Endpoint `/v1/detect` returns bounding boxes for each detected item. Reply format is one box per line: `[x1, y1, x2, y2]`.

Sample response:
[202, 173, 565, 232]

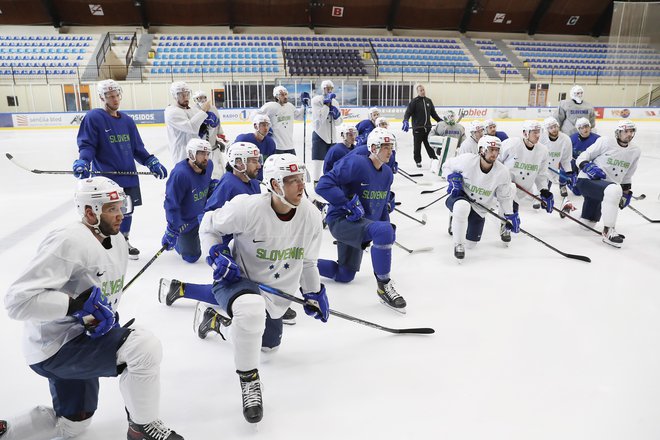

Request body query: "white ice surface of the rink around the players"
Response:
[0, 117, 660, 440]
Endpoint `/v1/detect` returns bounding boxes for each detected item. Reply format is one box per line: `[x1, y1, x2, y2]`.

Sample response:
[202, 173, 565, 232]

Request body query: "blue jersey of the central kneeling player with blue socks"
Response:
[316, 154, 394, 223]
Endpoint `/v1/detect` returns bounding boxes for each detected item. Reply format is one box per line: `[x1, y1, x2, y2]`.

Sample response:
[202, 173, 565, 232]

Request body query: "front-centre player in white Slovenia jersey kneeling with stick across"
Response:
[200, 154, 329, 423]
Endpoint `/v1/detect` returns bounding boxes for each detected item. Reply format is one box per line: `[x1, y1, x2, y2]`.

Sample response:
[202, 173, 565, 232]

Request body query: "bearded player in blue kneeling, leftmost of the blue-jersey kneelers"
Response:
[161, 139, 218, 263]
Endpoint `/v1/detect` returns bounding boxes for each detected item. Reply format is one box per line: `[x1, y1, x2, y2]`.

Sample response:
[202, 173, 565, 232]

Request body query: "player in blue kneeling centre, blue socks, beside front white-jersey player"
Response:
[316, 128, 406, 313]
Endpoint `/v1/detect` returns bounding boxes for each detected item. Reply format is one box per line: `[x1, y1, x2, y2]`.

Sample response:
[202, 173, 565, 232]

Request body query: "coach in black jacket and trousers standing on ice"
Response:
[402, 84, 440, 168]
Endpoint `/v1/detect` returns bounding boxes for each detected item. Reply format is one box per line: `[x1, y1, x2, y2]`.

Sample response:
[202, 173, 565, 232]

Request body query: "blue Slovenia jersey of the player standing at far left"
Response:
[78, 108, 151, 188]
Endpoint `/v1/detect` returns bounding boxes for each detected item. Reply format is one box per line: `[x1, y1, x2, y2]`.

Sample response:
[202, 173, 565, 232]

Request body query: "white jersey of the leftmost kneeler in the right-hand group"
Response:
[442, 154, 513, 217]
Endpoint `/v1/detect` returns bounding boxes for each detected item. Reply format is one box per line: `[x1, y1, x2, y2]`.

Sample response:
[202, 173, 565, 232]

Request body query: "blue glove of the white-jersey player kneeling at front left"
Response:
[67, 286, 119, 339]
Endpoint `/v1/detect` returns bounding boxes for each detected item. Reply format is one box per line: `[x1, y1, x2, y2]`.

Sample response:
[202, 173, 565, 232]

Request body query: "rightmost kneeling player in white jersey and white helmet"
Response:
[571, 120, 641, 247]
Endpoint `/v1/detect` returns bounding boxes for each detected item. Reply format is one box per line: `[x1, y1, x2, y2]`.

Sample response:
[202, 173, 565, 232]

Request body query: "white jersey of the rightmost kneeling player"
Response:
[575, 136, 642, 184]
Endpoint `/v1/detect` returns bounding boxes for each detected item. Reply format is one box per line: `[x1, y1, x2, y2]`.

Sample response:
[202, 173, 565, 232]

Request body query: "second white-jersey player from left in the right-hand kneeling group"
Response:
[499, 120, 554, 242]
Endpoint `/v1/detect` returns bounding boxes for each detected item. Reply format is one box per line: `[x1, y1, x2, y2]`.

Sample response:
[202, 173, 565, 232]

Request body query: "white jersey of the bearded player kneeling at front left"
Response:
[5, 222, 128, 365]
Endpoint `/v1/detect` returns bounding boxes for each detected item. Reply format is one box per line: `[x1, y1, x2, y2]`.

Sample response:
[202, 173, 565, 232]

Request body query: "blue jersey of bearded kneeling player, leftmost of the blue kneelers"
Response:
[164, 159, 213, 233]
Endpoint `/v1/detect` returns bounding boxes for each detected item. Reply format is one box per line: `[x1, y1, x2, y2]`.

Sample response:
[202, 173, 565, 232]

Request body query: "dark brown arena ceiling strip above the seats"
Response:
[0, 0, 628, 37]
